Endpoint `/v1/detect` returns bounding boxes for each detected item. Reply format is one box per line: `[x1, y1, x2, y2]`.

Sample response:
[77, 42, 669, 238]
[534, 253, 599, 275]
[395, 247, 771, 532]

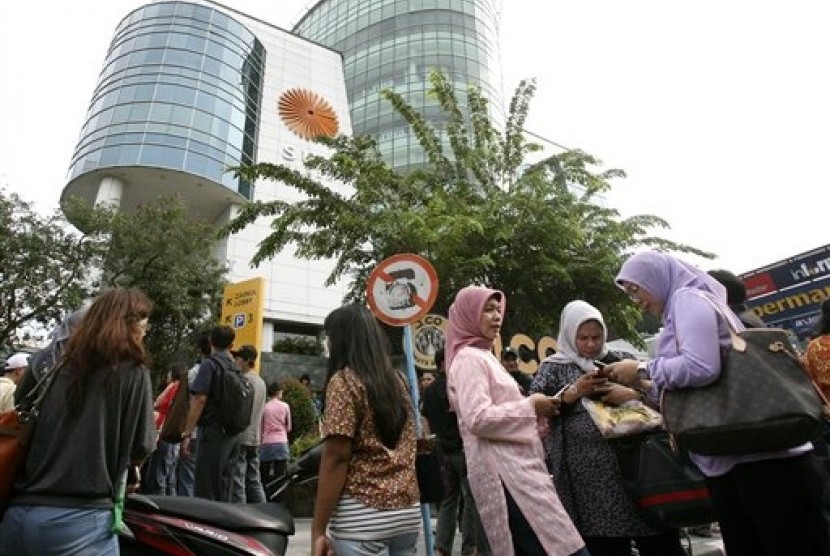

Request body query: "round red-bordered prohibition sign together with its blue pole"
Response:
[366, 253, 438, 556]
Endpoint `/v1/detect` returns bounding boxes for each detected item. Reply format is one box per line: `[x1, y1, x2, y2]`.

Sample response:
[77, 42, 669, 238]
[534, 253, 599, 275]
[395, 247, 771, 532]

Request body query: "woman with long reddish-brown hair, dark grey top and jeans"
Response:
[0, 288, 155, 556]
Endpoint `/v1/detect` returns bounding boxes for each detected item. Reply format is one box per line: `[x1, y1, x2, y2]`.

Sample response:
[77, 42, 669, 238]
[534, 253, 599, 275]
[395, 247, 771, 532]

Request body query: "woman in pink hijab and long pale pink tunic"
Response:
[445, 286, 588, 556]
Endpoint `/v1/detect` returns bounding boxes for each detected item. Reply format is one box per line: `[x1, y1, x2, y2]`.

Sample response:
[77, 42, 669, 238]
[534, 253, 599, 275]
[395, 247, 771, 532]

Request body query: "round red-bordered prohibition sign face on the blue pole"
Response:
[366, 253, 438, 326]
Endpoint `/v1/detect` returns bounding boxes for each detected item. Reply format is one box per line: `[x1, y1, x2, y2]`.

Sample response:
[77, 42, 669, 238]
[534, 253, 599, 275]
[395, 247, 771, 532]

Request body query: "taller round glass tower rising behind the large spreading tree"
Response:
[293, 0, 504, 169]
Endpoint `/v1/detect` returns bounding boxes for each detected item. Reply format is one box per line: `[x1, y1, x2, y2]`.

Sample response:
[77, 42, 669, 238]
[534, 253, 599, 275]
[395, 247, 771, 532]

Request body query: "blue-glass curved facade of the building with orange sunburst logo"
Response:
[69, 2, 265, 199]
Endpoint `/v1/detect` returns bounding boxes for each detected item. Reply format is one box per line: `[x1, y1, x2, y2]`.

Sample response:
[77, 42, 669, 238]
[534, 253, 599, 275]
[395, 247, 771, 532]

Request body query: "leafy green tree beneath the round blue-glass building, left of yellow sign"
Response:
[64, 196, 226, 384]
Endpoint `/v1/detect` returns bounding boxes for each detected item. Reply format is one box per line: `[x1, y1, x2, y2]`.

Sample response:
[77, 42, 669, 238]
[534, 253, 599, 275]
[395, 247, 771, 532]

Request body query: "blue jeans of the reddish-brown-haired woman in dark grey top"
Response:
[0, 506, 118, 556]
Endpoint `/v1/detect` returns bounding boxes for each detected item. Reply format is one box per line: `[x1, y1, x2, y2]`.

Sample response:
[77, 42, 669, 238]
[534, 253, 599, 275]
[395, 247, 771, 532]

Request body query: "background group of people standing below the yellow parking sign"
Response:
[135, 326, 291, 503]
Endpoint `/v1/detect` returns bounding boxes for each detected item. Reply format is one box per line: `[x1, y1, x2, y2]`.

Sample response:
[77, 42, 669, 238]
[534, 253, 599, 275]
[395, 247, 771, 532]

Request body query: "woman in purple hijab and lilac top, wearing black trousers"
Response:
[606, 251, 830, 556]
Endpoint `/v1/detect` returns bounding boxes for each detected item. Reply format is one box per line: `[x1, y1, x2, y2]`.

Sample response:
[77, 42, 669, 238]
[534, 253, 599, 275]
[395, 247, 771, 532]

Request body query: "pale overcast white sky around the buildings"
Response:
[0, 0, 830, 273]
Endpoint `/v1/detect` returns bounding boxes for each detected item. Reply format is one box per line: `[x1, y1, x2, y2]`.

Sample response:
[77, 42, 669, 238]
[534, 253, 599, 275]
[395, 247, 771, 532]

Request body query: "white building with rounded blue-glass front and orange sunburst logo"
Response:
[63, 0, 351, 338]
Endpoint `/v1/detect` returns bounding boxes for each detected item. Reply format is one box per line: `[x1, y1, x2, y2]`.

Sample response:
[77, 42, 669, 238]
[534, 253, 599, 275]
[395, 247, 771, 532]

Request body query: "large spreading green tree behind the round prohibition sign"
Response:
[228, 72, 711, 340]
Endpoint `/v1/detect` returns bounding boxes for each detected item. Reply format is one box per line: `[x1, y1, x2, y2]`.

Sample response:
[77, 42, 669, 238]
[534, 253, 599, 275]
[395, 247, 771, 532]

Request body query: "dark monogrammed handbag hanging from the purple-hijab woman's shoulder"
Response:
[661, 294, 822, 456]
